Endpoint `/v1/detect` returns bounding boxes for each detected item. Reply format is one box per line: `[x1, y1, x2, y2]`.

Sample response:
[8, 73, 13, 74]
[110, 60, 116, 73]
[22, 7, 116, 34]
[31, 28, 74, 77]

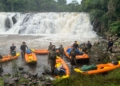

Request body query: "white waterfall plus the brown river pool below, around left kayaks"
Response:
[0, 12, 98, 73]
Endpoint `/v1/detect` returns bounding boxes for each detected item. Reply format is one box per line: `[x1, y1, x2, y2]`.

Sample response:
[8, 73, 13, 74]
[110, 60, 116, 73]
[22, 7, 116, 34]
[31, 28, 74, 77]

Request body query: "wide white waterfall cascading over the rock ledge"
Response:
[0, 12, 98, 45]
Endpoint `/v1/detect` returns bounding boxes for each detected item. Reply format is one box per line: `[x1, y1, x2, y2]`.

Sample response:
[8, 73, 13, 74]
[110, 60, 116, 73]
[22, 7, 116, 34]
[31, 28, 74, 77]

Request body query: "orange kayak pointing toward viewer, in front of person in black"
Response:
[25, 53, 37, 63]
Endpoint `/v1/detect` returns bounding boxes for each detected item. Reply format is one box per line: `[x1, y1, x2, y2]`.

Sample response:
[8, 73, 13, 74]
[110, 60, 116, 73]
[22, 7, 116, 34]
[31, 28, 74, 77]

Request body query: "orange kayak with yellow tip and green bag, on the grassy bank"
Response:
[74, 61, 120, 75]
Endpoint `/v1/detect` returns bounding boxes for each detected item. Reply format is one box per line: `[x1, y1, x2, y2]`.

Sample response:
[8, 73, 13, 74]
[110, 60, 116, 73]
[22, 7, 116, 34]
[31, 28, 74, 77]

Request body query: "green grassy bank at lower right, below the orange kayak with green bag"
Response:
[53, 69, 120, 86]
